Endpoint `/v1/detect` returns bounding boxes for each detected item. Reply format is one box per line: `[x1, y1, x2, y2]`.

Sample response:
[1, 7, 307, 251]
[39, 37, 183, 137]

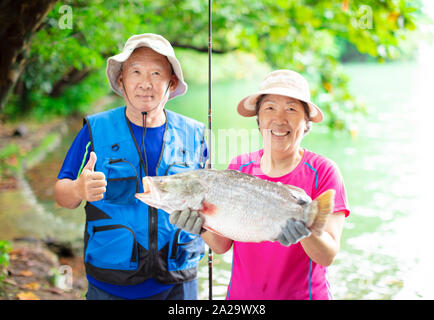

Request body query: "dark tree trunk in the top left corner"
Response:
[0, 0, 57, 111]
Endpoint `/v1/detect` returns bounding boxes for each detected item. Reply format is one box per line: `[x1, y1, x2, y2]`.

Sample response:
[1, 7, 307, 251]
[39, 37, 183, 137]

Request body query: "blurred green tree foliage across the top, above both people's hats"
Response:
[4, 0, 421, 129]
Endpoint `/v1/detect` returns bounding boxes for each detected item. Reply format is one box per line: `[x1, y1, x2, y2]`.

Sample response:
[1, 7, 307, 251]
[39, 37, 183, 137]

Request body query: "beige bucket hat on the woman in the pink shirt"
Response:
[237, 70, 323, 122]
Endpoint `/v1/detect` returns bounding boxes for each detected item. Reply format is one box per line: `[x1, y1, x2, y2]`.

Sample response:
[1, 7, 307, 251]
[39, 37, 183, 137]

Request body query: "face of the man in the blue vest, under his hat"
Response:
[117, 47, 178, 120]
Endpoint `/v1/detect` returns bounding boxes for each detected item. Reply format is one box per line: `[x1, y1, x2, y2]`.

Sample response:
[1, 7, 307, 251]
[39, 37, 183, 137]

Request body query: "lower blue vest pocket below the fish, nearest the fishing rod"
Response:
[168, 229, 205, 271]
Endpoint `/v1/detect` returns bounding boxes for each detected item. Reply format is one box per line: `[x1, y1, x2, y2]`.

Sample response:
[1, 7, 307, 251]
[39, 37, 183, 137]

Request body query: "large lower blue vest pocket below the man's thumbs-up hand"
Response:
[85, 224, 138, 270]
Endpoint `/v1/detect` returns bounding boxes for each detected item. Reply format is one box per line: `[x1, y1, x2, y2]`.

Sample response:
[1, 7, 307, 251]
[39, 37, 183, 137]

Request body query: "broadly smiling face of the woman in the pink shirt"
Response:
[258, 94, 307, 153]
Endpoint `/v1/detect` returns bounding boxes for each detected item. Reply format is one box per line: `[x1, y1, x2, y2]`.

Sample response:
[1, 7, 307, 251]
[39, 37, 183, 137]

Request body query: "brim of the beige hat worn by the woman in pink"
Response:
[237, 88, 324, 123]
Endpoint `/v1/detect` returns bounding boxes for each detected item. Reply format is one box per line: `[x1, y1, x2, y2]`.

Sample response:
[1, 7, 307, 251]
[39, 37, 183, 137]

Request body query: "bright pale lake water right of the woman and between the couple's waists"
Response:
[201, 53, 434, 299]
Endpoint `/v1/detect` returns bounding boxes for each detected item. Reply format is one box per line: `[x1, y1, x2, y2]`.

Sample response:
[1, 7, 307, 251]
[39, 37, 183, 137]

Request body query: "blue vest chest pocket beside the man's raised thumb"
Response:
[104, 159, 139, 205]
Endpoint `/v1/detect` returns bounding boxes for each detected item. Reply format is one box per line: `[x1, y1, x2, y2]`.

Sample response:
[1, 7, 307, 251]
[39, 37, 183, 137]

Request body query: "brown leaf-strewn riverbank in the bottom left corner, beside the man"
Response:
[0, 239, 87, 300]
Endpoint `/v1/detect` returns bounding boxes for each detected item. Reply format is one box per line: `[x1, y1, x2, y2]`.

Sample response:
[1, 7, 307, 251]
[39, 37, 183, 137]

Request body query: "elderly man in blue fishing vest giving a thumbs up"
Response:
[55, 33, 206, 299]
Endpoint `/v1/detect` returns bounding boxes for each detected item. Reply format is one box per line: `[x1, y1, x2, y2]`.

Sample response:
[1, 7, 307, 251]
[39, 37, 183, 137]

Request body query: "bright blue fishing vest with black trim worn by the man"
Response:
[84, 107, 205, 285]
